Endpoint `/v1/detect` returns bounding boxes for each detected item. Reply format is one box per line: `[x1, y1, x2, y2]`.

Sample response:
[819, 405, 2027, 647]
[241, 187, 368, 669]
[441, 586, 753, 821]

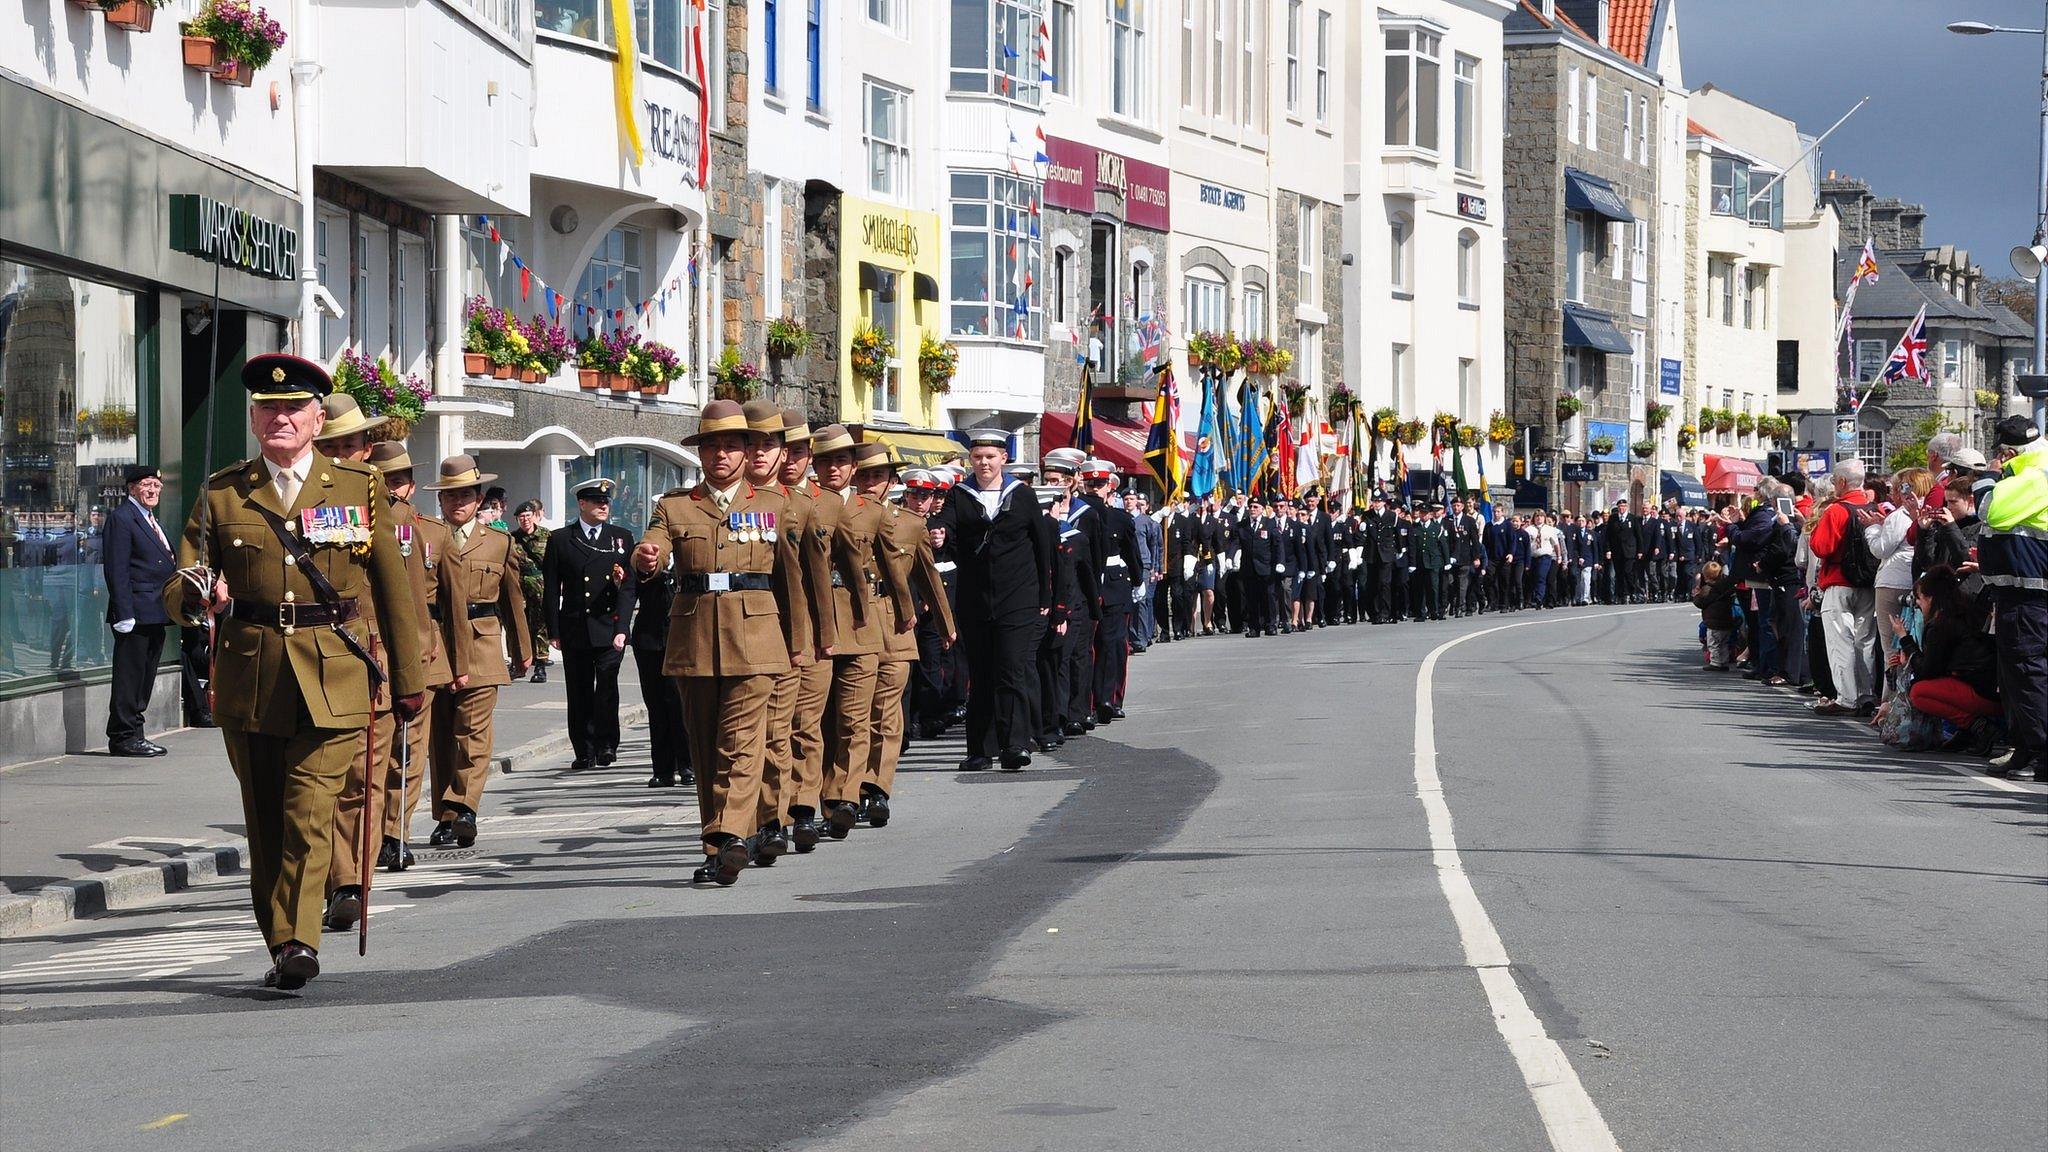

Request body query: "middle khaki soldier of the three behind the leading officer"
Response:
[371, 441, 463, 871]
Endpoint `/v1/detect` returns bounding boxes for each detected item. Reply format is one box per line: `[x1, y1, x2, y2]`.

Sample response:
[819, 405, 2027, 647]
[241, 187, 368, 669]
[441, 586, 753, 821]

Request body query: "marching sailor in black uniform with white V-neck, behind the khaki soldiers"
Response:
[934, 428, 1053, 773]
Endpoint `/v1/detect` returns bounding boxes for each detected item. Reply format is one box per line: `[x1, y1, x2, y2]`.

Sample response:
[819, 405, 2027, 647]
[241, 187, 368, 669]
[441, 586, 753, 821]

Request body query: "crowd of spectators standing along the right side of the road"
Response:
[1694, 416, 2048, 781]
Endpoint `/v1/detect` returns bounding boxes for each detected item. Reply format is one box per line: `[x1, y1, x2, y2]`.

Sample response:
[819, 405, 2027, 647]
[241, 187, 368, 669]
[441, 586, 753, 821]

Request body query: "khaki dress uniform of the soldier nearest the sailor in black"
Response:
[823, 481, 918, 824]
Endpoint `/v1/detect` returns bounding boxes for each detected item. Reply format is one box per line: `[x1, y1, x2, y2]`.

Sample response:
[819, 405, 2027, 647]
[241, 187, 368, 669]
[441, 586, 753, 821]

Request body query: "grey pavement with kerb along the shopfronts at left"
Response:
[0, 660, 647, 939]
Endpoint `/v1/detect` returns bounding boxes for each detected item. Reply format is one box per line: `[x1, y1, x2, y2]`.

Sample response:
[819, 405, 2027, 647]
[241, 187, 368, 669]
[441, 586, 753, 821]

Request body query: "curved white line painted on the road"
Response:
[1415, 605, 1669, 1152]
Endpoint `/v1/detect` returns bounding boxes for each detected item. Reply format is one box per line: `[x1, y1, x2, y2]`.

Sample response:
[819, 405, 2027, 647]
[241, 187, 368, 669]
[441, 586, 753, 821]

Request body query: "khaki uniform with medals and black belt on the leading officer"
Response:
[166, 444, 424, 949]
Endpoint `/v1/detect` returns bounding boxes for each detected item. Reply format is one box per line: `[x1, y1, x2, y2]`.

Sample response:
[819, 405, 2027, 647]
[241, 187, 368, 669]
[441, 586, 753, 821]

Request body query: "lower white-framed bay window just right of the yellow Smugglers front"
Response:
[946, 172, 1040, 342]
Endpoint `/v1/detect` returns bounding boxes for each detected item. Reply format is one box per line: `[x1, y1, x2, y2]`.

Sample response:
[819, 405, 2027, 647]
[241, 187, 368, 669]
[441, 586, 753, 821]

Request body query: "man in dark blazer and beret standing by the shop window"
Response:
[100, 463, 178, 756]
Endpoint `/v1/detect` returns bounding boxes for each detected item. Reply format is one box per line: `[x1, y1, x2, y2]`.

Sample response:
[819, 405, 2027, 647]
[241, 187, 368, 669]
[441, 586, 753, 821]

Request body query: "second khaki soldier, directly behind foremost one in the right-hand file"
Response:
[741, 400, 838, 865]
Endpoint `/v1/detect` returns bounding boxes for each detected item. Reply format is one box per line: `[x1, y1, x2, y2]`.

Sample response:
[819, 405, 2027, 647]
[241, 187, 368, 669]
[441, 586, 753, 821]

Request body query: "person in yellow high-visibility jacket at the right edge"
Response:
[1976, 407, 2048, 781]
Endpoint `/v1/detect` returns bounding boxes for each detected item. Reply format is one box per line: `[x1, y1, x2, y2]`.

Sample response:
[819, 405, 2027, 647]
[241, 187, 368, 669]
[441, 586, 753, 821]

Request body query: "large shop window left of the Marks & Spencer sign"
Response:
[0, 260, 144, 691]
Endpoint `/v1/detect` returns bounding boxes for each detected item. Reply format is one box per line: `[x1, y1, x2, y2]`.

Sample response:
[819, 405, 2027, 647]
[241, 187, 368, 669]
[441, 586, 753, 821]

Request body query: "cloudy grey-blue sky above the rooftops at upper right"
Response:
[1677, 0, 2048, 268]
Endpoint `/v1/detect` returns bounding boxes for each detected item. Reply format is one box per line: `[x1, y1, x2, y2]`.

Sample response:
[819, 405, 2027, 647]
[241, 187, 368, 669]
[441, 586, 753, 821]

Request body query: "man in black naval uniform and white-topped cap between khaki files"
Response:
[541, 476, 639, 771]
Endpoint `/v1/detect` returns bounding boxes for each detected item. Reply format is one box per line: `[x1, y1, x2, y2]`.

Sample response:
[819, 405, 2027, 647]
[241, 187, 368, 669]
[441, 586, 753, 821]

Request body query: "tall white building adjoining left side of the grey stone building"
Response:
[1343, 0, 1513, 486]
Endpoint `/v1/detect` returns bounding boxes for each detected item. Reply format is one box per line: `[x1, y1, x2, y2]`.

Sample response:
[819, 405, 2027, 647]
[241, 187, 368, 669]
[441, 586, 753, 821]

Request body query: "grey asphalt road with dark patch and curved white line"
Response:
[0, 609, 2048, 1152]
